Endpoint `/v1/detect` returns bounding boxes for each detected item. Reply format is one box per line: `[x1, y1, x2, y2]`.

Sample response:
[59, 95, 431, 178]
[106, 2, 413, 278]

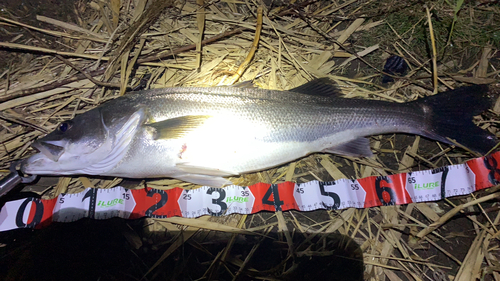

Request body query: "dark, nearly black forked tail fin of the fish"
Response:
[412, 85, 498, 155]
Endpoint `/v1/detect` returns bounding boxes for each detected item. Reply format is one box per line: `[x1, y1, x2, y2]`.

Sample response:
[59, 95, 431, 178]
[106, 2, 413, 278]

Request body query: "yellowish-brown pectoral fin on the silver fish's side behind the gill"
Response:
[145, 115, 211, 140]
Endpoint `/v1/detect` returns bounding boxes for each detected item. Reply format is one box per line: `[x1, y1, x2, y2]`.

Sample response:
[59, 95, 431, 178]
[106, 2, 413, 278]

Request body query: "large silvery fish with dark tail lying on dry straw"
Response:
[21, 78, 498, 187]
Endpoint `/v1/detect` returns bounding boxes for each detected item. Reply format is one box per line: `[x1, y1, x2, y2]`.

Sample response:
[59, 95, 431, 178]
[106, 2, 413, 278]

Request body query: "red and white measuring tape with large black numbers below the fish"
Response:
[0, 152, 500, 231]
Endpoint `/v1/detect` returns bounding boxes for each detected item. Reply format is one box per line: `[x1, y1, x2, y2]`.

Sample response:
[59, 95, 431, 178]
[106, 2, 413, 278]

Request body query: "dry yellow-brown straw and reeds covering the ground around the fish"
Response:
[0, 0, 500, 281]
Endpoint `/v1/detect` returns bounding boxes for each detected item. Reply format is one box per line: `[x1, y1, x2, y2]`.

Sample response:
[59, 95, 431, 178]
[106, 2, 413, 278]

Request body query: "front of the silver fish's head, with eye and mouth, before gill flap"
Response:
[23, 108, 113, 174]
